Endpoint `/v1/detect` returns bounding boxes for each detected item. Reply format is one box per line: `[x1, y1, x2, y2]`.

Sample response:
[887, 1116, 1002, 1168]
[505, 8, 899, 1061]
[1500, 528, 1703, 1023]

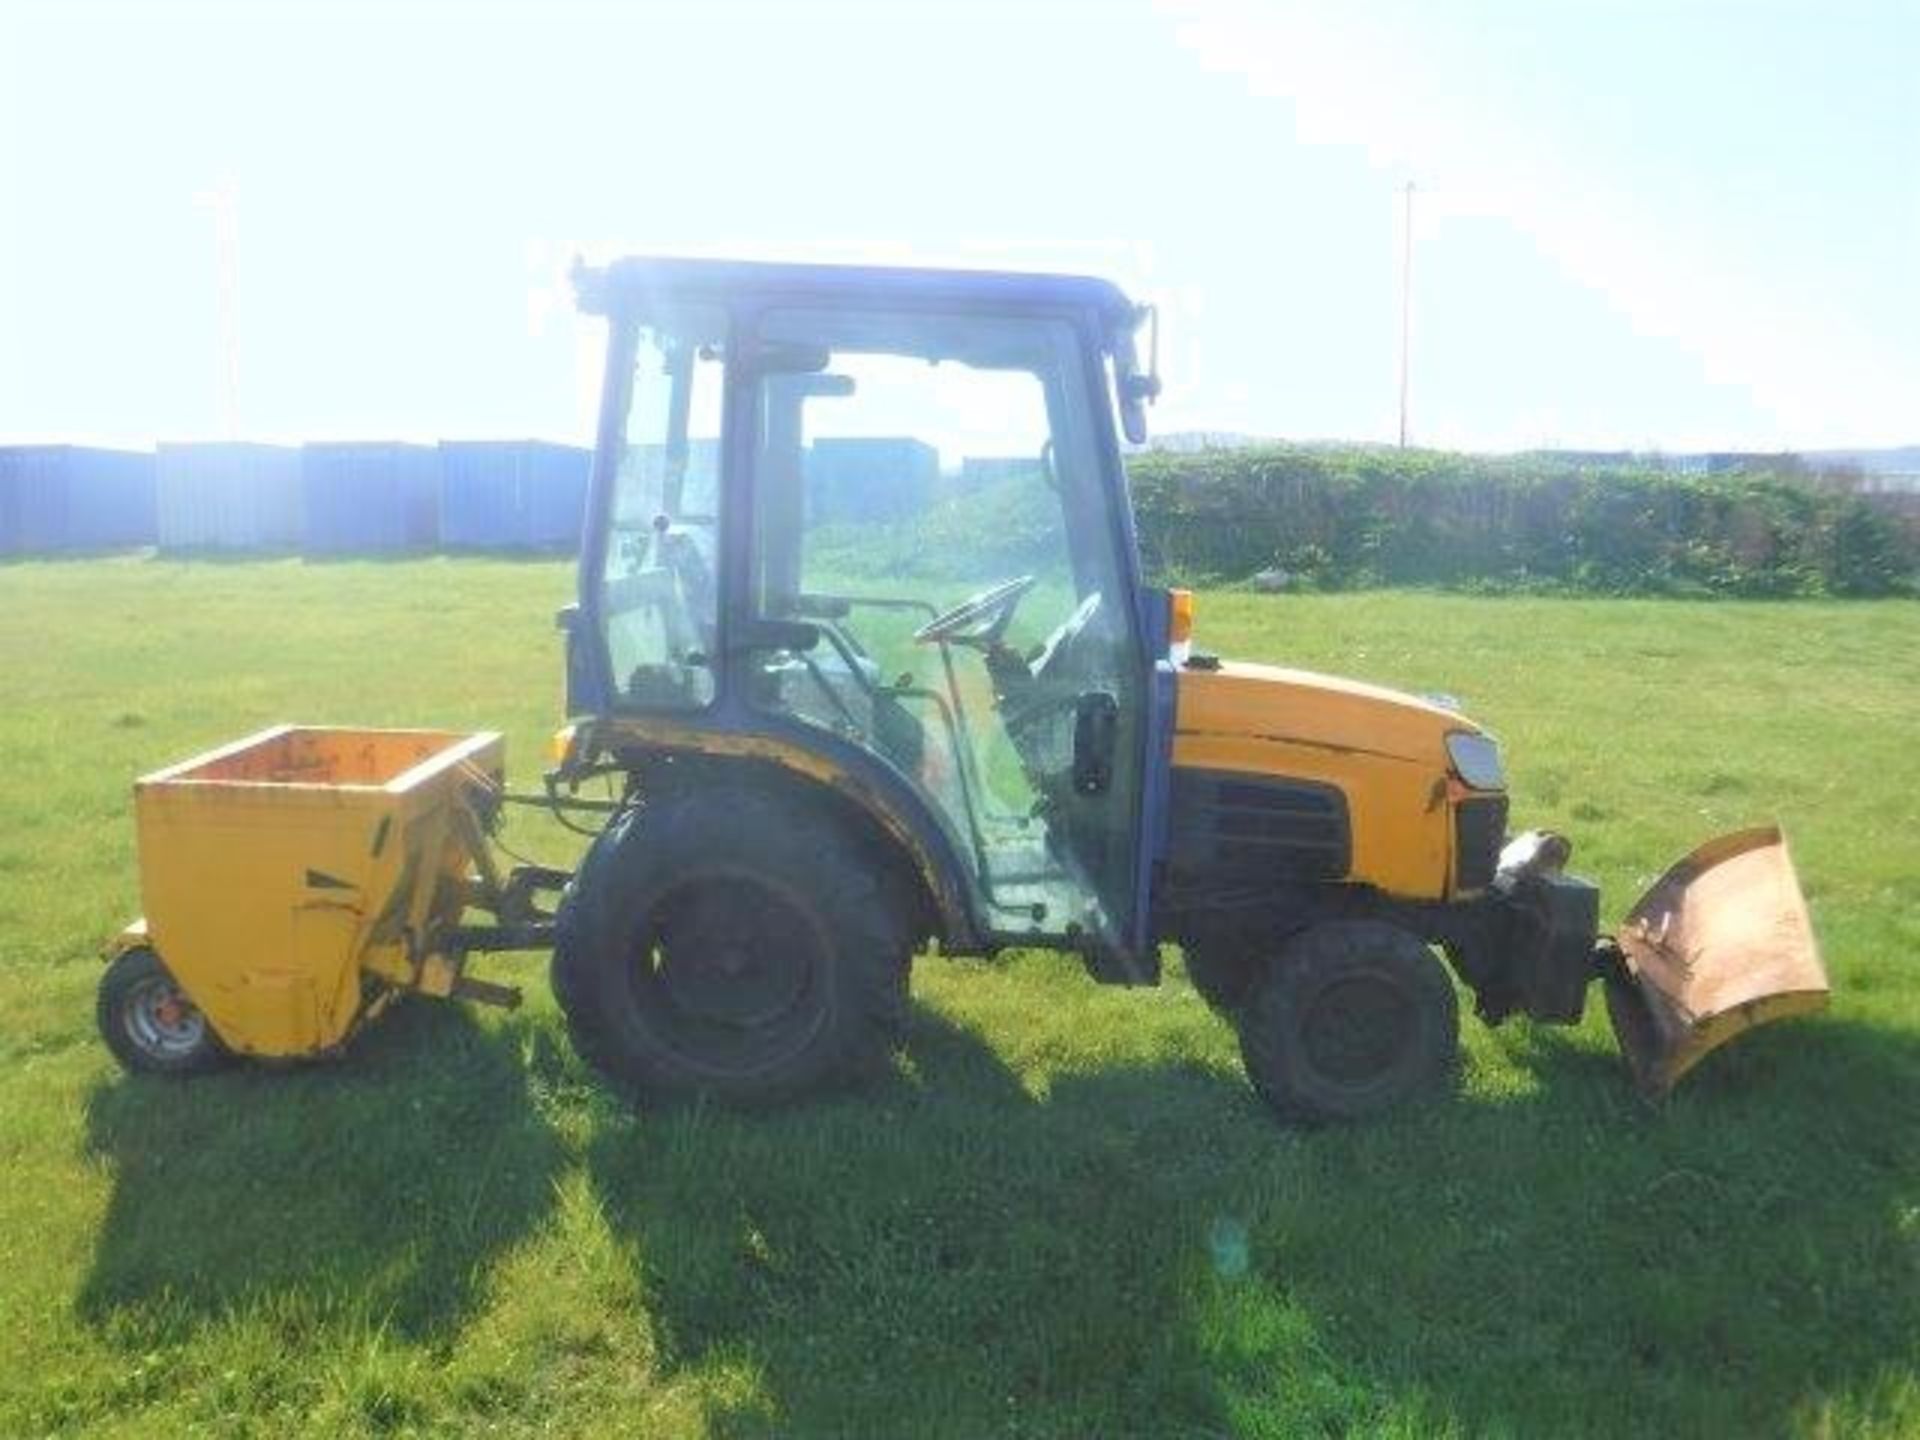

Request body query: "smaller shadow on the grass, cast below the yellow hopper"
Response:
[77, 1004, 564, 1344]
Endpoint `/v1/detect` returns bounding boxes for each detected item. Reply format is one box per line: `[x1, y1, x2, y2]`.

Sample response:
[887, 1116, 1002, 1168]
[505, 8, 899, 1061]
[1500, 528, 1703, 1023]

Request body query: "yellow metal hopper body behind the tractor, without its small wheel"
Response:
[121, 726, 505, 1056]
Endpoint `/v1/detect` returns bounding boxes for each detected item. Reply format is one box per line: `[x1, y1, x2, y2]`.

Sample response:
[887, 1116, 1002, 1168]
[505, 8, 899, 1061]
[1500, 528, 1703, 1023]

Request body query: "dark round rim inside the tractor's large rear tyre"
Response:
[632, 876, 829, 1075]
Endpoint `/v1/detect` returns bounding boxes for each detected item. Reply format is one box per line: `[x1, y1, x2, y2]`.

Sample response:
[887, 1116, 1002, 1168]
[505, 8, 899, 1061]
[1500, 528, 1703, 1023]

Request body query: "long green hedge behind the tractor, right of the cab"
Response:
[1127, 445, 1920, 597]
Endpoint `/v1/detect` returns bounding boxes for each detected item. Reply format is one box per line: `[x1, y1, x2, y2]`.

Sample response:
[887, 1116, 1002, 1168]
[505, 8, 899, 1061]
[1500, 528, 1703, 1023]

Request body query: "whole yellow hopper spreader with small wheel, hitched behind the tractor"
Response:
[100, 726, 566, 1073]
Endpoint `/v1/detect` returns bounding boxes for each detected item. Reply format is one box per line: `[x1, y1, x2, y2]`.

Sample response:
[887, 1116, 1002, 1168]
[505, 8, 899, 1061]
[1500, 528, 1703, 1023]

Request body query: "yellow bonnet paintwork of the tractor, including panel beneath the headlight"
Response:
[1173, 662, 1476, 900]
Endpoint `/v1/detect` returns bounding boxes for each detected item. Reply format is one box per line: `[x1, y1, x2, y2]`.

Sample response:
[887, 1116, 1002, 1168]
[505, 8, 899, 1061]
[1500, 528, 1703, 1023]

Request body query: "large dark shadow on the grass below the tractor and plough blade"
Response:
[588, 1006, 1920, 1436]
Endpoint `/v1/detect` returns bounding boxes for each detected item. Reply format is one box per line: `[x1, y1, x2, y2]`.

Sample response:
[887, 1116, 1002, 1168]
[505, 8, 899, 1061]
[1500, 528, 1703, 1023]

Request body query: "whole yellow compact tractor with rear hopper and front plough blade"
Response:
[100, 259, 1826, 1121]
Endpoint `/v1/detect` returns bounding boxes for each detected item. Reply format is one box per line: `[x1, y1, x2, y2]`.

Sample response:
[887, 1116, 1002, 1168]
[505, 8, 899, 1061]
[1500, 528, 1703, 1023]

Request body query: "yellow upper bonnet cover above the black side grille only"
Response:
[1175, 660, 1478, 768]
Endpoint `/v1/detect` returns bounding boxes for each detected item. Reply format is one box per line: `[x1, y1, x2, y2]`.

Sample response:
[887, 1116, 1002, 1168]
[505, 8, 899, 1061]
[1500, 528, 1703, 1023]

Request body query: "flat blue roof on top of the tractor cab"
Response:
[574, 255, 1133, 323]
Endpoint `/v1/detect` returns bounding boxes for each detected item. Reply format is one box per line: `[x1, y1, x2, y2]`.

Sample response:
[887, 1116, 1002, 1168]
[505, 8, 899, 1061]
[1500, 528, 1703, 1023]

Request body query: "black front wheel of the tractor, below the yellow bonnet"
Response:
[1240, 920, 1459, 1125]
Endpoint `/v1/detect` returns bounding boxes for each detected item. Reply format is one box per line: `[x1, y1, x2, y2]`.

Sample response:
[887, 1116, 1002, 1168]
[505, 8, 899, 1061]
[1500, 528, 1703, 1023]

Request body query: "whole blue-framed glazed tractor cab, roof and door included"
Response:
[570, 261, 1165, 964]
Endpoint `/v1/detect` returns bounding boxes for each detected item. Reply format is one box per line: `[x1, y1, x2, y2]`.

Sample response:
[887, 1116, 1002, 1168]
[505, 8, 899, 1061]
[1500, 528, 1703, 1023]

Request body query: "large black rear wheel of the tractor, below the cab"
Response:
[553, 785, 912, 1104]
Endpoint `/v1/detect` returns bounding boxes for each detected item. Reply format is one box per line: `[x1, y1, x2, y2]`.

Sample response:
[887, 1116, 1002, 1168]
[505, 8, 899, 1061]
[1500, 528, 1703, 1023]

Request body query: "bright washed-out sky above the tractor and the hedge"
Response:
[0, 0, 1920, 449]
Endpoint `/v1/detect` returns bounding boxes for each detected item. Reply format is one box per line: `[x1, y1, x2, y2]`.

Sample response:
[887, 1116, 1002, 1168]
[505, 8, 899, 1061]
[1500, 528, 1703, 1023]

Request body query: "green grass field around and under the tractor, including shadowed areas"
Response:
[0, 561, 1920, 1436]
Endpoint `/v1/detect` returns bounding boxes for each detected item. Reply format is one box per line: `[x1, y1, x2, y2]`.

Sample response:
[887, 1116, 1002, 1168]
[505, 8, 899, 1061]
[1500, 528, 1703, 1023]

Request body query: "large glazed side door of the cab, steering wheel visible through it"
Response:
[733, 305, 1148, 954]
